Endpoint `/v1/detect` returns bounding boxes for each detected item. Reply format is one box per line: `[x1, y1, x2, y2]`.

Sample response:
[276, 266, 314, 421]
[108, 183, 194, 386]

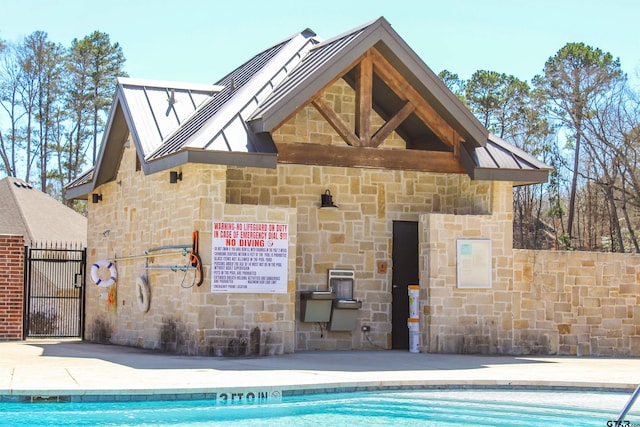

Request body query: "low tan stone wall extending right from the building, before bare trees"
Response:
[513, 250, 640, 356]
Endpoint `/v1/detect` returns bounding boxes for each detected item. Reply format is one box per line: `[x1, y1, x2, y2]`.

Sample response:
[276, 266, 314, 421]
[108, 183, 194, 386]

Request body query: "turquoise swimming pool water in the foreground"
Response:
[0, 389, 640, 427]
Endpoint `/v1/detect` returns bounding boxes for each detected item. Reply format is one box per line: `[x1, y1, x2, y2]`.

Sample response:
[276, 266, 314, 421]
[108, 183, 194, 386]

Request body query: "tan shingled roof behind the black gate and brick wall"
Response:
[0, 177, 87, 245]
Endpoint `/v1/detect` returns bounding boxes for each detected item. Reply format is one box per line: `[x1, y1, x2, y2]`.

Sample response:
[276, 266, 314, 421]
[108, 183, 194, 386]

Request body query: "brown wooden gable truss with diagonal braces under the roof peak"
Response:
[277, 48, 466, 173]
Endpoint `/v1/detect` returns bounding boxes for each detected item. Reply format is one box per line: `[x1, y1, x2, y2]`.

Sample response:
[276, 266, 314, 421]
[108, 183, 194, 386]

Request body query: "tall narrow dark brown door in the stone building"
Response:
[391, 221, 419, 350]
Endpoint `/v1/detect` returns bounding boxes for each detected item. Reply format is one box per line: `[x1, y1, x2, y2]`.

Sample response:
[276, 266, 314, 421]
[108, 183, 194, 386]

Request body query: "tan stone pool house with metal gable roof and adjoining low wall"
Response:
[67, 18, 640, 356]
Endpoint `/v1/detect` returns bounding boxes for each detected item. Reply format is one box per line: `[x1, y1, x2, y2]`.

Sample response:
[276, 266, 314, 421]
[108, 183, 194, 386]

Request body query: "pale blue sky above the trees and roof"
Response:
[0, 0, 640, 87]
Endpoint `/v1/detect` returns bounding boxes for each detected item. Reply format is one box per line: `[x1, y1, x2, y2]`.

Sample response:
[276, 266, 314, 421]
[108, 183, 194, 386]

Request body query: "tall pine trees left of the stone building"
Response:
[0, 31, 126, 204]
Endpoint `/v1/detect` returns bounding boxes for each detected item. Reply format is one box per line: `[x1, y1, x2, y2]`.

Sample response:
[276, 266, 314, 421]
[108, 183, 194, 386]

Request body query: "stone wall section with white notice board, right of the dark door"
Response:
[420, 182, 514, 354]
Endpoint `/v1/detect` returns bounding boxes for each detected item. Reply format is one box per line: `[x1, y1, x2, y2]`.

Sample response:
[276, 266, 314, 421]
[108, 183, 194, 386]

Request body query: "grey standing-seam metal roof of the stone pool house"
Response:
[67, 18, 550, 198]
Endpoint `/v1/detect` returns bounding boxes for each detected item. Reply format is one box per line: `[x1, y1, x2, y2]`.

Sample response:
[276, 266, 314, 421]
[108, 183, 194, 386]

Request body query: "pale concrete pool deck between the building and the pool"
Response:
[0, 340, 640, 401]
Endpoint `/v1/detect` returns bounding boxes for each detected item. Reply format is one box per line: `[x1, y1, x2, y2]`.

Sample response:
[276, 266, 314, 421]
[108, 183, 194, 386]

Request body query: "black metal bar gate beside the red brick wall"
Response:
[23, 242, 87, 338]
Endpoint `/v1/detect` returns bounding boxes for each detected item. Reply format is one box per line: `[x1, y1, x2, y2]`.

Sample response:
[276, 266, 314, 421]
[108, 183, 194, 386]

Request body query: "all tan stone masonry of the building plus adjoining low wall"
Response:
[86, 77, 640, 356]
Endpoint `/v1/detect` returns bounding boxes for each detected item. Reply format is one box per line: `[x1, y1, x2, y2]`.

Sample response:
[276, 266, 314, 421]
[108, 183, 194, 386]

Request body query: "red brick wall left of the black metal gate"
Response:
[0, 234, 24, 340]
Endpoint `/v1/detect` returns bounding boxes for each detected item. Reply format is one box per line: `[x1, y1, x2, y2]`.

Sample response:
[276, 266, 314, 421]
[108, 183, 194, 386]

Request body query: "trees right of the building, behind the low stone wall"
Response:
[439, 43, 640, 252]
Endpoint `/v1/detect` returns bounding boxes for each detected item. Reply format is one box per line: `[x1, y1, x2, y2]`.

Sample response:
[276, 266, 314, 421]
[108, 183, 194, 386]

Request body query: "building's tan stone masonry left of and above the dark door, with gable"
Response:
[86, 76, 496, 355]
